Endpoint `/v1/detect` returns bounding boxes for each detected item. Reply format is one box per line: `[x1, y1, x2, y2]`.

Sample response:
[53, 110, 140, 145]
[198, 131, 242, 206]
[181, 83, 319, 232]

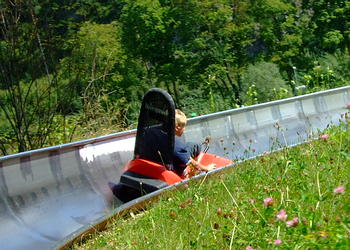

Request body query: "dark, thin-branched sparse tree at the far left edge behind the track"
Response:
[0, 1, 74, 154]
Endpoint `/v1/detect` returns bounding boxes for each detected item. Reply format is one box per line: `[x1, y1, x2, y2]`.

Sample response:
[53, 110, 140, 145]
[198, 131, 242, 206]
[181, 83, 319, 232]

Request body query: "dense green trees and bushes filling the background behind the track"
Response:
[0, 0, 350, 154]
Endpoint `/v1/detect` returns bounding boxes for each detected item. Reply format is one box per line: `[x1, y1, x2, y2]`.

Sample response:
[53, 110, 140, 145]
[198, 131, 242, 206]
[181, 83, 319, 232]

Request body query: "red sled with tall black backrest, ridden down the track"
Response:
[110, 88, 233, 202]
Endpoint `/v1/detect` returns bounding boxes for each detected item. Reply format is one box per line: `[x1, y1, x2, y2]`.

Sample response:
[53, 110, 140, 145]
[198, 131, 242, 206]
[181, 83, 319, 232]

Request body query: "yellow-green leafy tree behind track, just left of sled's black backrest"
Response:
[60, 22, 146, 130]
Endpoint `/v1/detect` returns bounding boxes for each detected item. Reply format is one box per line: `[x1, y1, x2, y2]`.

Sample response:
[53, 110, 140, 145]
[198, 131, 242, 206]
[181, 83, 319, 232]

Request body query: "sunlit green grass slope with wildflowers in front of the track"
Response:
[73, 120, 350, 249]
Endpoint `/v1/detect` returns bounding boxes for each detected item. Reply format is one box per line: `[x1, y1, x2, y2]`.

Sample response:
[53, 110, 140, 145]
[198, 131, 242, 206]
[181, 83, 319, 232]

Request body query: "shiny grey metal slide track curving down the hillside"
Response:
[0, 86, 350, 249]
